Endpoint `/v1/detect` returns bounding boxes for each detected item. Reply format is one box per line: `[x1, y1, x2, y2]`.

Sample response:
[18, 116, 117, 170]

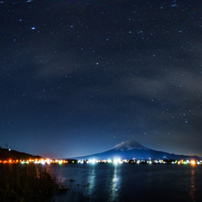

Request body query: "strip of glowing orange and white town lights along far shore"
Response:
[0, 158, 202, 166]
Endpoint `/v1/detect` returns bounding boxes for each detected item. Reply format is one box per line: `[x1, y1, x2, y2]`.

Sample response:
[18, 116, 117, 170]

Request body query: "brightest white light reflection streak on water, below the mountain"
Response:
[110, 165, 121, 201]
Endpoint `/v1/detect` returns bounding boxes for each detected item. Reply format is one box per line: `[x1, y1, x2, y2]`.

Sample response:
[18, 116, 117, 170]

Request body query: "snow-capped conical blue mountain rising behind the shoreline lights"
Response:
[76, 140, 200, 160]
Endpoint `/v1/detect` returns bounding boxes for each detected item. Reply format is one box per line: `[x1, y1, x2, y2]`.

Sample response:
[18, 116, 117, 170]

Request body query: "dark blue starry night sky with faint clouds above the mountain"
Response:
[0, 0, 202, 158]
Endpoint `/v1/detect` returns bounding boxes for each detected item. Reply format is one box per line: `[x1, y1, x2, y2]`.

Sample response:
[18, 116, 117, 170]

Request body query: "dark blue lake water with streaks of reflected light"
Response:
[50, 164, 202, 201]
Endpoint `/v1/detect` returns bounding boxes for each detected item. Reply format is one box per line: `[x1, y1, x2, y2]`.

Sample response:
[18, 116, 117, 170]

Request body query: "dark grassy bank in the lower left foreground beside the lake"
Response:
[0, 164, 58, 201]
